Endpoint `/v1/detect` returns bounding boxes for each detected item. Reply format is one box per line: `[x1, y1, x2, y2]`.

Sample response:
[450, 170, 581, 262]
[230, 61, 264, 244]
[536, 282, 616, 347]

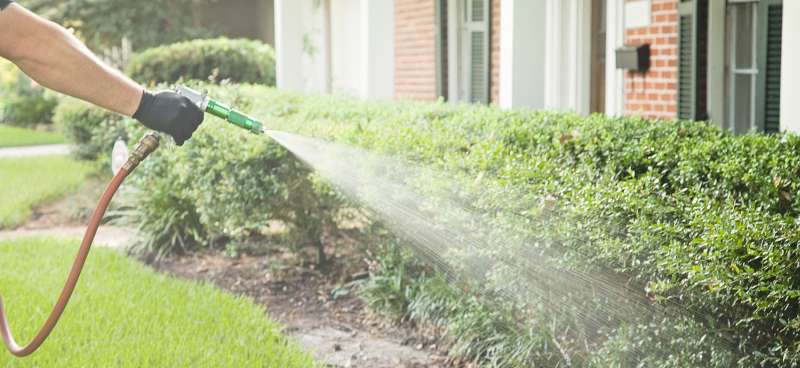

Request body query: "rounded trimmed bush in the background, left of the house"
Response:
[127, 38, 275, 86]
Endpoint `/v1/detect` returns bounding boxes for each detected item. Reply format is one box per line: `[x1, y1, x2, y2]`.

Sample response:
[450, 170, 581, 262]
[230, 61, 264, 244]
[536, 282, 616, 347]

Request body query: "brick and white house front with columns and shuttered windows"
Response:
[274, 0, 800, 132]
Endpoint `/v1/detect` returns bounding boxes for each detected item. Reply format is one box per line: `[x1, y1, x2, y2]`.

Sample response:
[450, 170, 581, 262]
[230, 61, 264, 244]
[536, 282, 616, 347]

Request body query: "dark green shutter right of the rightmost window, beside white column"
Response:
[764, 3, 783, 133]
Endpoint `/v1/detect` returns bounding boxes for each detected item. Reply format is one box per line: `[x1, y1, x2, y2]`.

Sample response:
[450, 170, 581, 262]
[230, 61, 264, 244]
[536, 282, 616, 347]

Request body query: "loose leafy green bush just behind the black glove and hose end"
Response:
[57, 85, 341, 266]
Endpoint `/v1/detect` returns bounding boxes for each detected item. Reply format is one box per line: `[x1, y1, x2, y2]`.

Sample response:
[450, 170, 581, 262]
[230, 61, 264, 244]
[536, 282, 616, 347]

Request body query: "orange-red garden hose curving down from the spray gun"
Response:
[0, 133, 158, 357]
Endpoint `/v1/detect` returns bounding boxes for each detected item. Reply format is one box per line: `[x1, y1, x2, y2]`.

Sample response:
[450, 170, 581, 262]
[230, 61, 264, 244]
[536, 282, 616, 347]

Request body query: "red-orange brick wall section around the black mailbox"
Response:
[625, 0, 678, 119]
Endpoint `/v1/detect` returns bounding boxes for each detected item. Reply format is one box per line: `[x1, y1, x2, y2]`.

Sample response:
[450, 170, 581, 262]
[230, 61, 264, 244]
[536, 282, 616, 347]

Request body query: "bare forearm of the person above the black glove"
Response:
[0, 4, 143, 116]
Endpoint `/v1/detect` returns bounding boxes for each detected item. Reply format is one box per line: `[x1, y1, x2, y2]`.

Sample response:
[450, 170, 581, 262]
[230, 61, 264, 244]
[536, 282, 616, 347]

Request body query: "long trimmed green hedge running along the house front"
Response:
[241, 85, 800, 366]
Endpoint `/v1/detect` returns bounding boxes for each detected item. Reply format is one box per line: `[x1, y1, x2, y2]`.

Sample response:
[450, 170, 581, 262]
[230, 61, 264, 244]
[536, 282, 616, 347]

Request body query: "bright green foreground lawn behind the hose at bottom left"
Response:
[0, 239, 314, 368]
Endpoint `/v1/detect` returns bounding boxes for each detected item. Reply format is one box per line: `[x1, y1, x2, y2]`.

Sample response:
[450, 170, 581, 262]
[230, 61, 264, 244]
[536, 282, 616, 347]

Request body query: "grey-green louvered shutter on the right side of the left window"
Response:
[466, 0, 491, 103]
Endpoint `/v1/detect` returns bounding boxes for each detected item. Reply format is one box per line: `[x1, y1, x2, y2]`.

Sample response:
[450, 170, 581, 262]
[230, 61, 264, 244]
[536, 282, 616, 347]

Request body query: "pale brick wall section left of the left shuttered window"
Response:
[394, 0, 436, 100]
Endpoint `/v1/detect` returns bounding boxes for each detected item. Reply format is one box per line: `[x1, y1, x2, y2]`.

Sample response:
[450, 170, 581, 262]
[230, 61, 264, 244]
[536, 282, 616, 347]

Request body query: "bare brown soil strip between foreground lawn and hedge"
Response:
[153, 250, 462, 368]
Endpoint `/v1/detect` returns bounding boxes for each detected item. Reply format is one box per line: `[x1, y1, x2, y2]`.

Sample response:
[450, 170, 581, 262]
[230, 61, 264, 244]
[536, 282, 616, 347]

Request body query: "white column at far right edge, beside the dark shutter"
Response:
[781, 0, 800, 133]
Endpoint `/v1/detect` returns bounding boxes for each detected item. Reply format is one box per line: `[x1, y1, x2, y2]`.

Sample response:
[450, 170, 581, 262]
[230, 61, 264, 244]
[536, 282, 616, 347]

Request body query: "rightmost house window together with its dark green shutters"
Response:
[678, 0, 783, 133]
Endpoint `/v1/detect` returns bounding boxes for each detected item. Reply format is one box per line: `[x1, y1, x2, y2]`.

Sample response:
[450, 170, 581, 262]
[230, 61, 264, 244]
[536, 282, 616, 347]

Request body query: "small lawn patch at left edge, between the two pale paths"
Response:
[0, 156, 92, 229]
